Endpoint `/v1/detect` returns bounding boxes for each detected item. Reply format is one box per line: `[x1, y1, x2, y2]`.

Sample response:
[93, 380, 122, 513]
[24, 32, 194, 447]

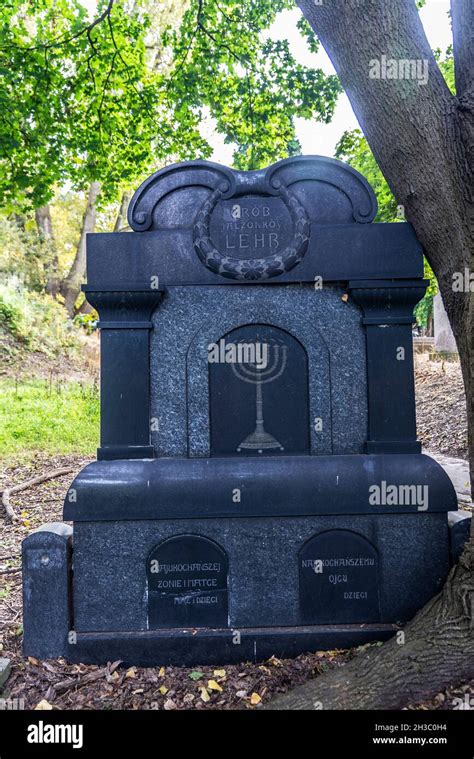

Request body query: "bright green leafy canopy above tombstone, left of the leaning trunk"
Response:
[0, 0, 340, 210]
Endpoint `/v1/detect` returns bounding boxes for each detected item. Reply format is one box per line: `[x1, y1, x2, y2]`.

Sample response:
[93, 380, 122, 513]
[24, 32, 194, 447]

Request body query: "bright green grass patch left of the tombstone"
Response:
[0, 379, 99, 458]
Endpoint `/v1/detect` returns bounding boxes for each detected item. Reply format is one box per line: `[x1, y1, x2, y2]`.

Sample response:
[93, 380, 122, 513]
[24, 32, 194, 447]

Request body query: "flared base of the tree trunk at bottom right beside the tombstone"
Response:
[265, 551, 474, 710]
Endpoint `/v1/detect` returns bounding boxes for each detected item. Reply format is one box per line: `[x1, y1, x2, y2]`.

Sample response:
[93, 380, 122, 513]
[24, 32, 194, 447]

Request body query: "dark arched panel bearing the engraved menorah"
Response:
[208, 323, 311, 456]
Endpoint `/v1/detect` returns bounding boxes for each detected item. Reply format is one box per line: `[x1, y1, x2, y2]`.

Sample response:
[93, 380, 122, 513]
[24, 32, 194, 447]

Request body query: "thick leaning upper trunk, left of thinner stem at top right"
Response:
[298, 0, 474, 348]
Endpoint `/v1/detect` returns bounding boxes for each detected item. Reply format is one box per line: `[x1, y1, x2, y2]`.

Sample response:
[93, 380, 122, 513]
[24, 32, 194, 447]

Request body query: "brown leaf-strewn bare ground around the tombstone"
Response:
[0, 362, 474, 710]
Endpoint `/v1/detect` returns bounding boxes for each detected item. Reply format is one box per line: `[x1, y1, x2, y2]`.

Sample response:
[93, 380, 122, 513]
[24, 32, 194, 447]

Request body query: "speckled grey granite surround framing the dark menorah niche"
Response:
[150, 285, 367, 457]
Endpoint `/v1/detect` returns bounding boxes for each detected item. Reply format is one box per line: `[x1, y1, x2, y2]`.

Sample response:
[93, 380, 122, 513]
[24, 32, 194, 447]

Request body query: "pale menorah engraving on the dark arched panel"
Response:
[232, 344, 287, 453]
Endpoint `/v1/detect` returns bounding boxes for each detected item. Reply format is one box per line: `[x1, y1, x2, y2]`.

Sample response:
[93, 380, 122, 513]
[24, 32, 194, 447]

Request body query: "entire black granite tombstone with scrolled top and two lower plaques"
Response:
[23, 156, 465, 665]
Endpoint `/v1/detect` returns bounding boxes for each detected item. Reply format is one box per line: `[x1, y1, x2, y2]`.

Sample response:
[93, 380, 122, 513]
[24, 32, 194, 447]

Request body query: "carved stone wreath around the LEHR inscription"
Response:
[193, 185, 310, 280]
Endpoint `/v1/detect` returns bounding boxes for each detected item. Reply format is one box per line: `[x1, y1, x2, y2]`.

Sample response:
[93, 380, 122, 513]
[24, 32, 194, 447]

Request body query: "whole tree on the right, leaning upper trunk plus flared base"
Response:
[270, 0, 474, 709]
